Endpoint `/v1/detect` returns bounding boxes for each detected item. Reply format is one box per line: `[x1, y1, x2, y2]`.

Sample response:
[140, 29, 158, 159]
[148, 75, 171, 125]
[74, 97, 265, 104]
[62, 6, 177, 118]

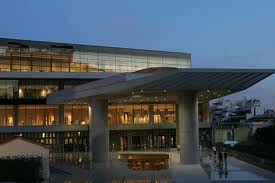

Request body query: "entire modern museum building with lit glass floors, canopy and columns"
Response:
[0, 38, 274, 164]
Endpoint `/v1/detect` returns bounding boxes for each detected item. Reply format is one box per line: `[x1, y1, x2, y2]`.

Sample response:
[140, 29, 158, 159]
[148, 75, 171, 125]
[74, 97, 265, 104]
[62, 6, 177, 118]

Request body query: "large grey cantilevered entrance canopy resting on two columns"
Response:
[47, 69, 275, 104]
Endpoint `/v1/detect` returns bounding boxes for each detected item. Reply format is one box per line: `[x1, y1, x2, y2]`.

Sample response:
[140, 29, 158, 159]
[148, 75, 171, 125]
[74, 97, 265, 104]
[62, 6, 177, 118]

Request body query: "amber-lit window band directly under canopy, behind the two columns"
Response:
[0, 104, 209, 126]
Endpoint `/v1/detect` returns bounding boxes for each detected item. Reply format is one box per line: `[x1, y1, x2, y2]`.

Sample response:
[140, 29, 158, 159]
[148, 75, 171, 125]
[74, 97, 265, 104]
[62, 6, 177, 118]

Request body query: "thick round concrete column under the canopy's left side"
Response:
[89, 99, 109, 165]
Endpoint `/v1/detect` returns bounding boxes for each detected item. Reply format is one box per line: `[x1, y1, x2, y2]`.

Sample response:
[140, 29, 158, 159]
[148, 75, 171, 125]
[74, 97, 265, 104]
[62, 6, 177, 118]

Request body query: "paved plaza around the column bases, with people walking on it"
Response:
[51, 150, 275, 183]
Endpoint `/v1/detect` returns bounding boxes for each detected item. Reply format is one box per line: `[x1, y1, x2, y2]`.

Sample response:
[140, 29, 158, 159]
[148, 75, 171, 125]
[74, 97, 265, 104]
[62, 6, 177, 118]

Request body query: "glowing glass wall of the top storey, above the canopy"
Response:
[0, 46, 191, 72]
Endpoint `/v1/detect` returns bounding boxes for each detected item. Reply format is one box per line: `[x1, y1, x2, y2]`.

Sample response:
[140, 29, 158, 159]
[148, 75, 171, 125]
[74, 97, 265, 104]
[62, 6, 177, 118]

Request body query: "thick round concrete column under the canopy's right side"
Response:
[178, 91, 200, 164]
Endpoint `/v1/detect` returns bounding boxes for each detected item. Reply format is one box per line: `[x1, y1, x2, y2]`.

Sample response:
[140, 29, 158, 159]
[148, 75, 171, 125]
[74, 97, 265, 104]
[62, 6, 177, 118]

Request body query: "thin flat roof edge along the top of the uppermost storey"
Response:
[0, 38, 191, 59]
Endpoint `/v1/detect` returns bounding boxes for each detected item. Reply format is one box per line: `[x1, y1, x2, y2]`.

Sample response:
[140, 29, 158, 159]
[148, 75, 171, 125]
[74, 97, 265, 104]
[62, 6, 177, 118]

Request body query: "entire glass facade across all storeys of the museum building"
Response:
[0, 39, 211, 151]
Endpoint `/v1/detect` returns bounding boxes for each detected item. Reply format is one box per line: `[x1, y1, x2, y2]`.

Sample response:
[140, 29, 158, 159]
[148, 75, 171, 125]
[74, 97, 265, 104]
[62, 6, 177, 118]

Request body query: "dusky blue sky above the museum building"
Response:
[0, 0, 275, 108]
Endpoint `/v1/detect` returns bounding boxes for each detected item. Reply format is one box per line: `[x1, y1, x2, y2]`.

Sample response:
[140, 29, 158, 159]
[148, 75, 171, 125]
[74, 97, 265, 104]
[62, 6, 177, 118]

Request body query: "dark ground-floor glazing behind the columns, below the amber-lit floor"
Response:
[0, 128, 212, 152]
